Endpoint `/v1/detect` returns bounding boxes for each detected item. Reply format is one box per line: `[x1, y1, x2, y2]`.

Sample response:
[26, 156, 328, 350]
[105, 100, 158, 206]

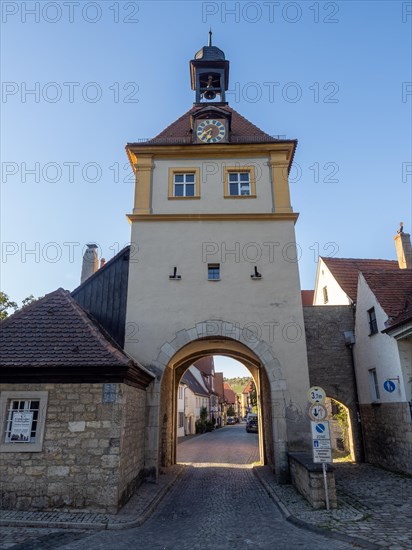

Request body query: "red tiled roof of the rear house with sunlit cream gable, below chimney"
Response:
[322, 257, 400, 302]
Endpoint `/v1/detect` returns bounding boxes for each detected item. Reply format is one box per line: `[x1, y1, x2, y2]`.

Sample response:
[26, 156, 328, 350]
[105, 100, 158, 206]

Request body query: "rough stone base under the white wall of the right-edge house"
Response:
[361, 403, 412, 475]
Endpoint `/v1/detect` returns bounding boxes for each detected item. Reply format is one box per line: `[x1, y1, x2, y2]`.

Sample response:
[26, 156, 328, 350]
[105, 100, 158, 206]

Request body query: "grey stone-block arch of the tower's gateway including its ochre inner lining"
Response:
[146, 319, 288, 480]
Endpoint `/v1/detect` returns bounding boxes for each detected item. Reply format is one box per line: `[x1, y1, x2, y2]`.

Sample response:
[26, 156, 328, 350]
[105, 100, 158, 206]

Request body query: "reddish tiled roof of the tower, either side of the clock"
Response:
[129, 105, 295, 146]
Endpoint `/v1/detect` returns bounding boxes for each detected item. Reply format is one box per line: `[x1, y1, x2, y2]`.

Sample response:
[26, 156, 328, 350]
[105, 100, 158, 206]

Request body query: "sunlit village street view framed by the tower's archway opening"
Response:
[176, 355, 262, 468]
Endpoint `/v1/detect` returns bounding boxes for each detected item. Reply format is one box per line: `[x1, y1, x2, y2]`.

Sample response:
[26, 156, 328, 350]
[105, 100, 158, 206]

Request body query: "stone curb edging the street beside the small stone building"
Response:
[0, 466, 184, 530]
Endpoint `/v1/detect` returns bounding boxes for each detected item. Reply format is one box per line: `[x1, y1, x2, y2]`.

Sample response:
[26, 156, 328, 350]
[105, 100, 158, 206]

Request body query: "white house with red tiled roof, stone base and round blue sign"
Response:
[353, 256, 412, 474]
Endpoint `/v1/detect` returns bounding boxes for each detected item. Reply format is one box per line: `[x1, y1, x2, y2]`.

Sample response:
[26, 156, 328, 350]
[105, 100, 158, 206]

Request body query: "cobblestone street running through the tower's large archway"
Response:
[3, 424, 355, 550]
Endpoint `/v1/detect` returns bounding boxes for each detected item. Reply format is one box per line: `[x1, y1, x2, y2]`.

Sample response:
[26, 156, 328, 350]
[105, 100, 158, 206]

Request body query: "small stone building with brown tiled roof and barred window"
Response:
[0, 289, 154, 512]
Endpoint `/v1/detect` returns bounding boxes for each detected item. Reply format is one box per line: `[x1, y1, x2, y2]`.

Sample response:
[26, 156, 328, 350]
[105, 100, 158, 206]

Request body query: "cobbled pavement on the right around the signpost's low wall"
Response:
[256, 464, 412, 550]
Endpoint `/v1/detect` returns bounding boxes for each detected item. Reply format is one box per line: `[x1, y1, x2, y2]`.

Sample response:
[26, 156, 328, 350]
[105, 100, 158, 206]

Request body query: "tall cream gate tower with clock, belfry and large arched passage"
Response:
[125, 38, 309, 484]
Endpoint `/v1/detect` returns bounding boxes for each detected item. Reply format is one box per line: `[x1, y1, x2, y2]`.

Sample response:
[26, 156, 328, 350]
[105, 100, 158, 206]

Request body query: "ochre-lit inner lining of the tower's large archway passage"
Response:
[159, 338, 276, 476]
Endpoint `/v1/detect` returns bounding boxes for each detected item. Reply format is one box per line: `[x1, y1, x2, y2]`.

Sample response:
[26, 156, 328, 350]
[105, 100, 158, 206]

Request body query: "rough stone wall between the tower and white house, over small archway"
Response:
[303, 306, 363, 461]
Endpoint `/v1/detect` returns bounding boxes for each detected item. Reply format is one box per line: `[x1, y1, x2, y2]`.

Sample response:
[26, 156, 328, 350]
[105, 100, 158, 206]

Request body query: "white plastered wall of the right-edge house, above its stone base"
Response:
[353, 273, 406, 404]
